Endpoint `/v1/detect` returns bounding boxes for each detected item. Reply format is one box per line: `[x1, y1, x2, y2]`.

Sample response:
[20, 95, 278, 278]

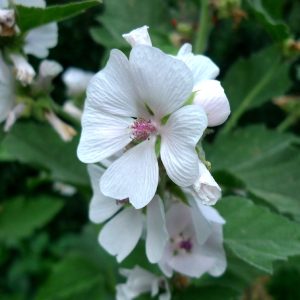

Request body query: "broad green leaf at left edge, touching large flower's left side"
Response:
[0, 122, 89, 185]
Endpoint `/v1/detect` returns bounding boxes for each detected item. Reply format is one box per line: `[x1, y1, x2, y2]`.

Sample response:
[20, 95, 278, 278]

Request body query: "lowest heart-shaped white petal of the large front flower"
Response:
[100, 139, 158, 208]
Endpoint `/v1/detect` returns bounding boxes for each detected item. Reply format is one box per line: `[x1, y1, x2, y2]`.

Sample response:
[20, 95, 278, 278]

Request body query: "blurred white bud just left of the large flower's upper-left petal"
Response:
[62, 68, 94, 96]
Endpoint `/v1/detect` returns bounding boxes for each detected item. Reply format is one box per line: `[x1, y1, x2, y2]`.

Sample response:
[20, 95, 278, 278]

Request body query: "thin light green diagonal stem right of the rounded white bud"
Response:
[222, 63, 277, 134]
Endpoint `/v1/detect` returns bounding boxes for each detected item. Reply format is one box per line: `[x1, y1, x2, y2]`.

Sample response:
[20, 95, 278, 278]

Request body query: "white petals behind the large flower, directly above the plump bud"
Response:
[177, 44, 220, 85]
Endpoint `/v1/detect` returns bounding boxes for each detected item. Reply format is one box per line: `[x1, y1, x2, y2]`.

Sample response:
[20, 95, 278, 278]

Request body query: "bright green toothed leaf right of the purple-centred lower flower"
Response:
[217, 197, 300, 273]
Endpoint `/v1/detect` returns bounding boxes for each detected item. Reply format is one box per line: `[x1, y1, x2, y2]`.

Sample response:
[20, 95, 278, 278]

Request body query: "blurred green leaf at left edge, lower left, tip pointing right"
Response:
[0, 196, 63, 242]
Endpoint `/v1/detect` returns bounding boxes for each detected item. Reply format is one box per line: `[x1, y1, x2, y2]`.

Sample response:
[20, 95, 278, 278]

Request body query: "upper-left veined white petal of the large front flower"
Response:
[86, 49, 146, 117]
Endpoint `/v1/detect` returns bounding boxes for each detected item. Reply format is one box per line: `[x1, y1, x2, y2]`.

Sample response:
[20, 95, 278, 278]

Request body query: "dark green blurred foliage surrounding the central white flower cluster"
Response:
[0, 0, 300, 300]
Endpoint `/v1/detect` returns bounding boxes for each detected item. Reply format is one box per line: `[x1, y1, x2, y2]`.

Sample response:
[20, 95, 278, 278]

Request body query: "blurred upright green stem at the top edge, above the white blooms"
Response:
[194, 0, 211, 53]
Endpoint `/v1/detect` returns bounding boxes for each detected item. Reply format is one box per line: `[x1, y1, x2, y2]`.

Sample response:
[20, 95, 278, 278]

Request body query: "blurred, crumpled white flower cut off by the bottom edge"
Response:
[116, 266, 171, 300]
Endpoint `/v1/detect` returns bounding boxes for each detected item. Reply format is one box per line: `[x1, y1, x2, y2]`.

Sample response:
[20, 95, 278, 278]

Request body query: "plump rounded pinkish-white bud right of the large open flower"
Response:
[194, 80, 230, 127]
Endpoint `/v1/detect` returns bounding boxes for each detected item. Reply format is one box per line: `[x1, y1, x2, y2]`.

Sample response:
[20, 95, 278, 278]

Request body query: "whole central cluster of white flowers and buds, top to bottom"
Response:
[78, 26, 230, 299]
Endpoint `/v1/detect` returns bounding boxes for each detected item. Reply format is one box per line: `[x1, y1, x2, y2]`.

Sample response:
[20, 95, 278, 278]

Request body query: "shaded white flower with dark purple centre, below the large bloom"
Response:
[159, 200, 226, 278]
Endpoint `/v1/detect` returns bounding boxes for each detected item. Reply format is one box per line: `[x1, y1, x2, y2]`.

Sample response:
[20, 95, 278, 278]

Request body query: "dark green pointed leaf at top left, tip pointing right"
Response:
[17, 0, 101, 32]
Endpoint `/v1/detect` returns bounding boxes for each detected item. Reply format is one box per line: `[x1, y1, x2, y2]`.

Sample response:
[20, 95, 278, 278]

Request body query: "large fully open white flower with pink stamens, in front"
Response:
[78, 45, 207, 208]
